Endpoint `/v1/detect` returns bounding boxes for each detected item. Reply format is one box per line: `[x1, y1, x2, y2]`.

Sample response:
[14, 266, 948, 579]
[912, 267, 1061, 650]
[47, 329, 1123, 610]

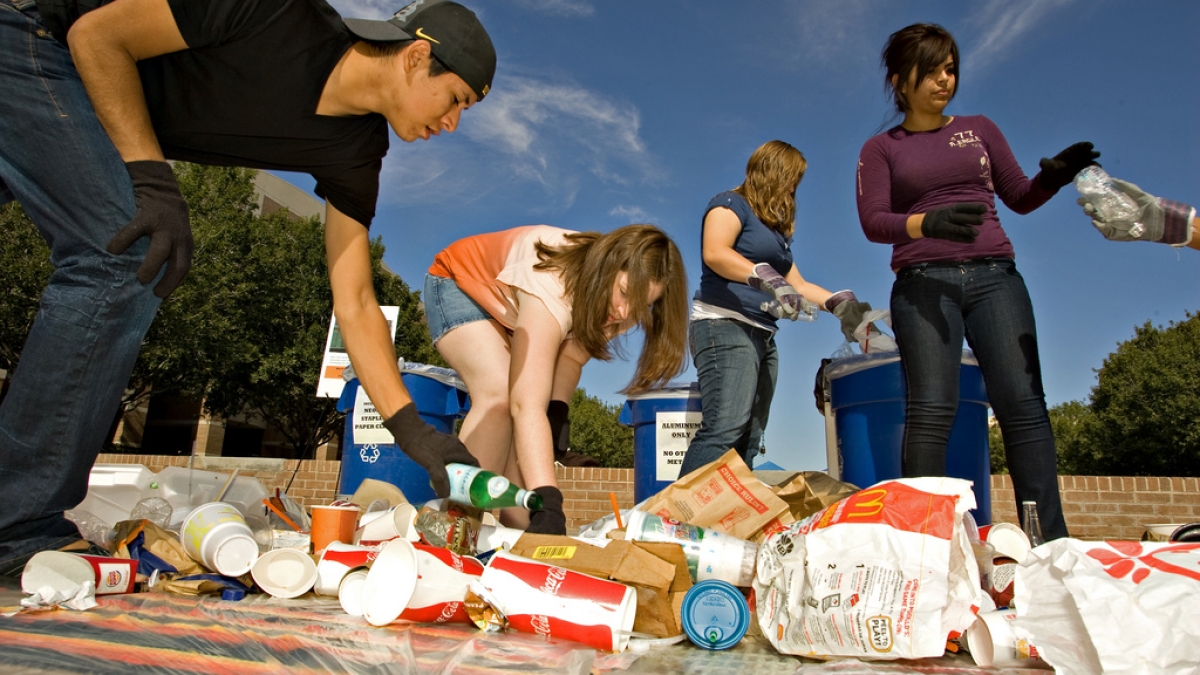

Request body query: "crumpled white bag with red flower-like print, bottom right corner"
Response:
[1013, 539, 1200, 675]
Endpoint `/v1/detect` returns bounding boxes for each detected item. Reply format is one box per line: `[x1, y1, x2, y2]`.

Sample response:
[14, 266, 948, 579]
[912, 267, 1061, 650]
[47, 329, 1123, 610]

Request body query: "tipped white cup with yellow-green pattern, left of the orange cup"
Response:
[179, 502, 258, 577]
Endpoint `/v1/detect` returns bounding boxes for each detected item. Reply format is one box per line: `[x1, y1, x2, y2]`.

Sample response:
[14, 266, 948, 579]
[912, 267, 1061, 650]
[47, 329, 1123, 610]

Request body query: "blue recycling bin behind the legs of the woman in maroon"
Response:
[826, 351, 991, 525]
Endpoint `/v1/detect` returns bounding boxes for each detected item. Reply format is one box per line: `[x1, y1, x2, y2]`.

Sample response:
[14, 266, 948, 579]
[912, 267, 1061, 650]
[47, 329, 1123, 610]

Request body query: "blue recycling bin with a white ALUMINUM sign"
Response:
[617, 382, 701, 502]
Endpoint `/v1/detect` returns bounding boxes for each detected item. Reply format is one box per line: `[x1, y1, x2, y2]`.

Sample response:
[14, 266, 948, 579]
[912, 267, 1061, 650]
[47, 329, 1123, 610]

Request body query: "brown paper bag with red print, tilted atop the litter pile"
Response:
[643, 449, 794, 540]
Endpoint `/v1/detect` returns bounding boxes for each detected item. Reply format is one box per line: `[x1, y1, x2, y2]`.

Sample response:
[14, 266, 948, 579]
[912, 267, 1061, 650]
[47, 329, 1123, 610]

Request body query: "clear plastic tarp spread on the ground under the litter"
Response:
[0, 579, 1046, 675]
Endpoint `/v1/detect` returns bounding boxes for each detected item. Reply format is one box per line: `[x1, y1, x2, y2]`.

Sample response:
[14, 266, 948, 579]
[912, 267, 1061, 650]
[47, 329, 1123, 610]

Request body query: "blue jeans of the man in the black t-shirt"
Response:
[0, 0, 158, 569]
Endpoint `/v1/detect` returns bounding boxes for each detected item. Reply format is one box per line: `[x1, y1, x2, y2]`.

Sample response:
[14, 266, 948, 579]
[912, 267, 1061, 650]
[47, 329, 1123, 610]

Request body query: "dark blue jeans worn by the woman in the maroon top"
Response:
[892, 258, 1067, 540]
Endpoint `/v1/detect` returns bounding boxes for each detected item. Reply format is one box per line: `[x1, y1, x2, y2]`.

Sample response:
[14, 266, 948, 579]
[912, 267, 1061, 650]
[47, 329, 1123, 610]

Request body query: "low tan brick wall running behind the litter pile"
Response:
[97, 454, 1200, 539]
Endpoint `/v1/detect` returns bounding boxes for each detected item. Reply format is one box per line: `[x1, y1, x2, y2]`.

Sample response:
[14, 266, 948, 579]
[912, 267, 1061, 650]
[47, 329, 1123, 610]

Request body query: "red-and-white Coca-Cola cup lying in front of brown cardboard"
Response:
[480, 551, 637, 651]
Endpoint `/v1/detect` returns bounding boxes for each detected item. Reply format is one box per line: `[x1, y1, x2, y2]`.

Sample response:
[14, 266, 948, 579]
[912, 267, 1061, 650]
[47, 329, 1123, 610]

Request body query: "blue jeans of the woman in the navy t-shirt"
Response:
[679, 318, 779, 476]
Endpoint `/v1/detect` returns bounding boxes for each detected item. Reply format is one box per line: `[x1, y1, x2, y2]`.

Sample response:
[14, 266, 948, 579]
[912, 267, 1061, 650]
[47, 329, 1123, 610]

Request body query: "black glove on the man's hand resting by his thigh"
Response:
[107, 160, 192, 298]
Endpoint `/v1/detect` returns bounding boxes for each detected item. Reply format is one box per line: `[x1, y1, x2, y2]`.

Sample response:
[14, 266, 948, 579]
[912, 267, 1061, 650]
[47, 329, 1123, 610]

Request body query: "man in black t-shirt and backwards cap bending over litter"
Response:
[0, 0, 496, 574]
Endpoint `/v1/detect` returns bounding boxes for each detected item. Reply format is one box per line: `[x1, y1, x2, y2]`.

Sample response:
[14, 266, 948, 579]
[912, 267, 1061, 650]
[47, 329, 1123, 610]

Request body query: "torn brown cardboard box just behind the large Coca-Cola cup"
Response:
[512, 533, 691, 638]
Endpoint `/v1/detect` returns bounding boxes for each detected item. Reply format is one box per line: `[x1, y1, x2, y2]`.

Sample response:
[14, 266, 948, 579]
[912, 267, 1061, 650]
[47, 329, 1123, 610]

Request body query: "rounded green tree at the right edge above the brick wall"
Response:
[1091, 312, 1200, 476]
